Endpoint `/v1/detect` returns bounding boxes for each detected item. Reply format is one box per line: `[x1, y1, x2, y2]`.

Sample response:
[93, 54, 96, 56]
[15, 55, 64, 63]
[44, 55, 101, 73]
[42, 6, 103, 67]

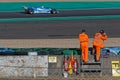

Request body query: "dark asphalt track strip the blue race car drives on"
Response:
[0, 9, 120, 19]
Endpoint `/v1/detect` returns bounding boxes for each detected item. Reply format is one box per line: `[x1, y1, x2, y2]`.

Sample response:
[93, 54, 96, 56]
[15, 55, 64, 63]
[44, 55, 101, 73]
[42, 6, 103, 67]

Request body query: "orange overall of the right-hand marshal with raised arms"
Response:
[93, 33, 108, 61]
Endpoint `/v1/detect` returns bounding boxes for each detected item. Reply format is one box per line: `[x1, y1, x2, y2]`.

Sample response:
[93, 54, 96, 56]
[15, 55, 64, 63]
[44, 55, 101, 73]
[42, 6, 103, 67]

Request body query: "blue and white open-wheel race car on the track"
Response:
[23, 6, 59, 14]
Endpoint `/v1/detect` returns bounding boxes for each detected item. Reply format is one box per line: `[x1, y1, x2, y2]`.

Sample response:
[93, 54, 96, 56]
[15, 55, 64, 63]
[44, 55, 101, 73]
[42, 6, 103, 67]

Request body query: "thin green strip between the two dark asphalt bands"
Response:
[0, 15, 120, 22]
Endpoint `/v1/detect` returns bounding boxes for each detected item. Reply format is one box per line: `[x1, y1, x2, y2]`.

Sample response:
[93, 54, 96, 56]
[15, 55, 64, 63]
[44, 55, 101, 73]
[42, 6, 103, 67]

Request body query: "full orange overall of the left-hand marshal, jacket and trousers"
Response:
[79, 33, 89, 62]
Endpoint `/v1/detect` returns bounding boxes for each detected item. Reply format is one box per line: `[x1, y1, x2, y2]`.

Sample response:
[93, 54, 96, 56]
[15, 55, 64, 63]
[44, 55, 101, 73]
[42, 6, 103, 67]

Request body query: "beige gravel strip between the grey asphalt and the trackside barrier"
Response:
[0, 38, 120, 48]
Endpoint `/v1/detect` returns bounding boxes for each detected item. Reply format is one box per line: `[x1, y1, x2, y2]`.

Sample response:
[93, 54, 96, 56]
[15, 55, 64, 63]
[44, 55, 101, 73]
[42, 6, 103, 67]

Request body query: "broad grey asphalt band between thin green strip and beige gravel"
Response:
[0, 19, 120, 39]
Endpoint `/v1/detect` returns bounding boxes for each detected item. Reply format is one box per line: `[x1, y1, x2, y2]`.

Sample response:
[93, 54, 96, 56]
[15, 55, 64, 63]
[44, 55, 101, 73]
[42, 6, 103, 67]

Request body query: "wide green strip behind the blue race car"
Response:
[0, 2, 120, 11]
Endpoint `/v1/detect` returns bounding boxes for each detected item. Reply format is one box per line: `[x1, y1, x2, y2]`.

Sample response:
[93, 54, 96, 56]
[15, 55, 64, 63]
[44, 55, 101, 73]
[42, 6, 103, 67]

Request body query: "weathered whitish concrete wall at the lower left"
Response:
[0, 55, 48, 78]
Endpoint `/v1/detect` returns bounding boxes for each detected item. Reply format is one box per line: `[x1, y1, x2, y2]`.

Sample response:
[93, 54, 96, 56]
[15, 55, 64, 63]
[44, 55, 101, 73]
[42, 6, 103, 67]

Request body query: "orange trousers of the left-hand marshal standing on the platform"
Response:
[81, 45, 88, 62]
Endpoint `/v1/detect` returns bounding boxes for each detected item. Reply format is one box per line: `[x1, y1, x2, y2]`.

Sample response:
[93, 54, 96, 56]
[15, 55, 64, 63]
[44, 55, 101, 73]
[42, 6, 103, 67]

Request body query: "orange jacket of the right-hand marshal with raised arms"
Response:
[93, 33, 108, 48]
